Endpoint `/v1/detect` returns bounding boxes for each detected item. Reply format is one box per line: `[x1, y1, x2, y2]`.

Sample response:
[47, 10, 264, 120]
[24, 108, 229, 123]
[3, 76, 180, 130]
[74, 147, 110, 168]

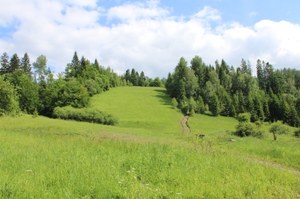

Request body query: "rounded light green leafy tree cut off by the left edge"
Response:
[0, 76, 19, 116]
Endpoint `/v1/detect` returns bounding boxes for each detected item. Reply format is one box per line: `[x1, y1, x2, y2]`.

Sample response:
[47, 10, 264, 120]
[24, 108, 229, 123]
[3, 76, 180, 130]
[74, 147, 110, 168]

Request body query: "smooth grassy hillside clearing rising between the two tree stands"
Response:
[91, 87, 181, 136]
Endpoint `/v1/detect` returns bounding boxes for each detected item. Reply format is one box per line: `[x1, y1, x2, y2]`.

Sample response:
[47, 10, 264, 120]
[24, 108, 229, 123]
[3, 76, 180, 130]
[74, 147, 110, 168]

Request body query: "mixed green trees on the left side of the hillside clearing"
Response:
[0, 52, 161, 123]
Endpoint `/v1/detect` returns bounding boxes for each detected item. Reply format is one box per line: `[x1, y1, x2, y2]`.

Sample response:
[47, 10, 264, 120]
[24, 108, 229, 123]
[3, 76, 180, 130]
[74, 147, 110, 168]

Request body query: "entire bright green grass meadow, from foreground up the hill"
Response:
[0, 87, 300, 198]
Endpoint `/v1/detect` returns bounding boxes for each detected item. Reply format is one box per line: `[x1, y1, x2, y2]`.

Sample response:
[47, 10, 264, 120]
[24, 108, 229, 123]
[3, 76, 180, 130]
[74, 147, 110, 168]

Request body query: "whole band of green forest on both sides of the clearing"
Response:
[0, 52, 300, 127]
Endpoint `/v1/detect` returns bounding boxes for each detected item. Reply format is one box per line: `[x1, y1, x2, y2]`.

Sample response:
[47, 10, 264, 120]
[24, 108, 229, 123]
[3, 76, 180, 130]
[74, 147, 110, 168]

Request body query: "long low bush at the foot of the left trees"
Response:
[53, 106, 118, 125]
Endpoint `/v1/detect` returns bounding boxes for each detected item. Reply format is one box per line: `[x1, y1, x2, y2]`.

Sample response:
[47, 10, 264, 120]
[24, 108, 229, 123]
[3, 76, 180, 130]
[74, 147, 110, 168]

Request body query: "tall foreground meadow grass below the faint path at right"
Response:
[0, 122, 300, 198]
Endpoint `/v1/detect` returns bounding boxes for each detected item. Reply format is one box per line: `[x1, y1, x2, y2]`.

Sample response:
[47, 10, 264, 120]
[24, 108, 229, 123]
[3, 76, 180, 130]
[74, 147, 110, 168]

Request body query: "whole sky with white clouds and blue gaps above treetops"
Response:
[0, 0, 300, 77]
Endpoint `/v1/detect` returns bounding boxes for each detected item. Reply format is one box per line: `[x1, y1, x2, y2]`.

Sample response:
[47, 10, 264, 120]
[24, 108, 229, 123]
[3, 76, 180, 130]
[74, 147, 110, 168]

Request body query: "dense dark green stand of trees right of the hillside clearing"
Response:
[166, 56, 300, 126]
